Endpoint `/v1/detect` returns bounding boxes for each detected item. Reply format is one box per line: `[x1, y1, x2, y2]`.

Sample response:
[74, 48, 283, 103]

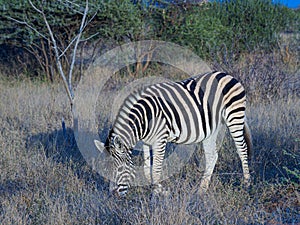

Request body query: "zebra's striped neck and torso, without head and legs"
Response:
[114, 72, 245, 145]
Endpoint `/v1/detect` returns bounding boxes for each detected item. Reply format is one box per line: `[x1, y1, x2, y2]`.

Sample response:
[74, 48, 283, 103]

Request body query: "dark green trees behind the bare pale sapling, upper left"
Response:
[0, 0, 144, 81]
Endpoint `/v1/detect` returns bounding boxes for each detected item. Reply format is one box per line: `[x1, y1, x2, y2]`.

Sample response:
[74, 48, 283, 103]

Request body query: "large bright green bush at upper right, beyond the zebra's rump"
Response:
[158, 0, 299, 58]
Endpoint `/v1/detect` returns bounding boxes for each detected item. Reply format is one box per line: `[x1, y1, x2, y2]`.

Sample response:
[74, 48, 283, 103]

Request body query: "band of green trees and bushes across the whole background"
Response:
[0, 0, 300, 81]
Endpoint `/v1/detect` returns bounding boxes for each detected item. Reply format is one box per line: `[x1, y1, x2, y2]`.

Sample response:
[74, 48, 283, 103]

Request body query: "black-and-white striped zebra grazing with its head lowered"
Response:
[94, 71, 252, 196]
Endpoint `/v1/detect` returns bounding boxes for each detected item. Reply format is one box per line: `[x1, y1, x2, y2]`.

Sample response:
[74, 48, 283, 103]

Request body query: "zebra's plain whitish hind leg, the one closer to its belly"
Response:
[200, 134, 218, 192]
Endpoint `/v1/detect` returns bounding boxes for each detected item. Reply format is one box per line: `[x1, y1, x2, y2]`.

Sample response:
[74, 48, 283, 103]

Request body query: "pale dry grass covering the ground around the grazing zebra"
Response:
[0, 64, 300, 224]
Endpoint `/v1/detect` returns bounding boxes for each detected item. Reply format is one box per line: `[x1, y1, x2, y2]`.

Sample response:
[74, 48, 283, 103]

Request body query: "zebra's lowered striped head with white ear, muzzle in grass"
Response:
[94, 133, 134, 197]
